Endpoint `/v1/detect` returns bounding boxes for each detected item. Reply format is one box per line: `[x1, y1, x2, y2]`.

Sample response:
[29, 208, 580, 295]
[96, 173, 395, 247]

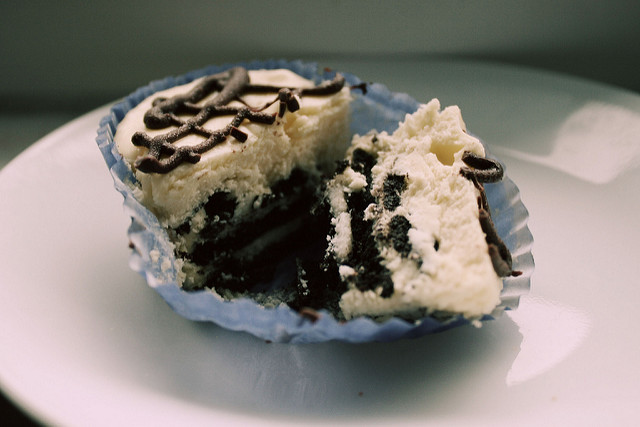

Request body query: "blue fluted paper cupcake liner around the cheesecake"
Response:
[96, 60, 534, 343]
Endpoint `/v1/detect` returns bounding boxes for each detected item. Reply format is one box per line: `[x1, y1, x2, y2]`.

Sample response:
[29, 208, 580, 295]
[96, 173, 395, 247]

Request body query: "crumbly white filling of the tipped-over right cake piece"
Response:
[329, 99, 502, 318]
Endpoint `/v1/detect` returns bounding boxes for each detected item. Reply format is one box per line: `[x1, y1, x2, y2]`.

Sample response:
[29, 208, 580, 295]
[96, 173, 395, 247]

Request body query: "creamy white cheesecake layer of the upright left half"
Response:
[114, 69, 351, 227]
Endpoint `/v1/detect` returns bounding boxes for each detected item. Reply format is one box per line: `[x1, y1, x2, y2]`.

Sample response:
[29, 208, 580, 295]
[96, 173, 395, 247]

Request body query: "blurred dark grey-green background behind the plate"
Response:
[0, 0, 640, 111]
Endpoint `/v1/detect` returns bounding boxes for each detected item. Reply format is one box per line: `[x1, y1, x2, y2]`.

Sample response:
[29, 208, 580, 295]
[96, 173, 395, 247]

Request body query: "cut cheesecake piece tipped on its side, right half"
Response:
[300, 99, 518, 319]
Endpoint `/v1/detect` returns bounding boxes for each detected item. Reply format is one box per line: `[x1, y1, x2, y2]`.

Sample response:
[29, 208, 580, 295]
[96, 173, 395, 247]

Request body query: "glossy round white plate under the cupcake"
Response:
[0, 61, 640, 425]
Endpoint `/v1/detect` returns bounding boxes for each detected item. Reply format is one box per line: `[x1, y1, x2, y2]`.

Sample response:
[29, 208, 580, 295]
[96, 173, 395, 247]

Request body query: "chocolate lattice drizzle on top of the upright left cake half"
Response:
[131, 67, 345, 173]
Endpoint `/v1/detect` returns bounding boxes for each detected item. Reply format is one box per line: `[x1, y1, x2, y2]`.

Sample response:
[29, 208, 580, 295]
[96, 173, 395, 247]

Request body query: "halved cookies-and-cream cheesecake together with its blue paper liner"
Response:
[97, 61, 533, 342]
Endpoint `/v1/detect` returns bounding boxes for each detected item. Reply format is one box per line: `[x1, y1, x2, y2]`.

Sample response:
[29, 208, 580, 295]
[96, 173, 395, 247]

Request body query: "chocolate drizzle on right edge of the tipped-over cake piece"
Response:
[460, 151, 522, 277]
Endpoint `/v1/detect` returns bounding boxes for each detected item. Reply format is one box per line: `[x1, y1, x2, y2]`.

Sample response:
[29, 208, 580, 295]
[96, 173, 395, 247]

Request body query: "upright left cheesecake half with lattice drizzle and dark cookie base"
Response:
[113, 67, 351, 292]
